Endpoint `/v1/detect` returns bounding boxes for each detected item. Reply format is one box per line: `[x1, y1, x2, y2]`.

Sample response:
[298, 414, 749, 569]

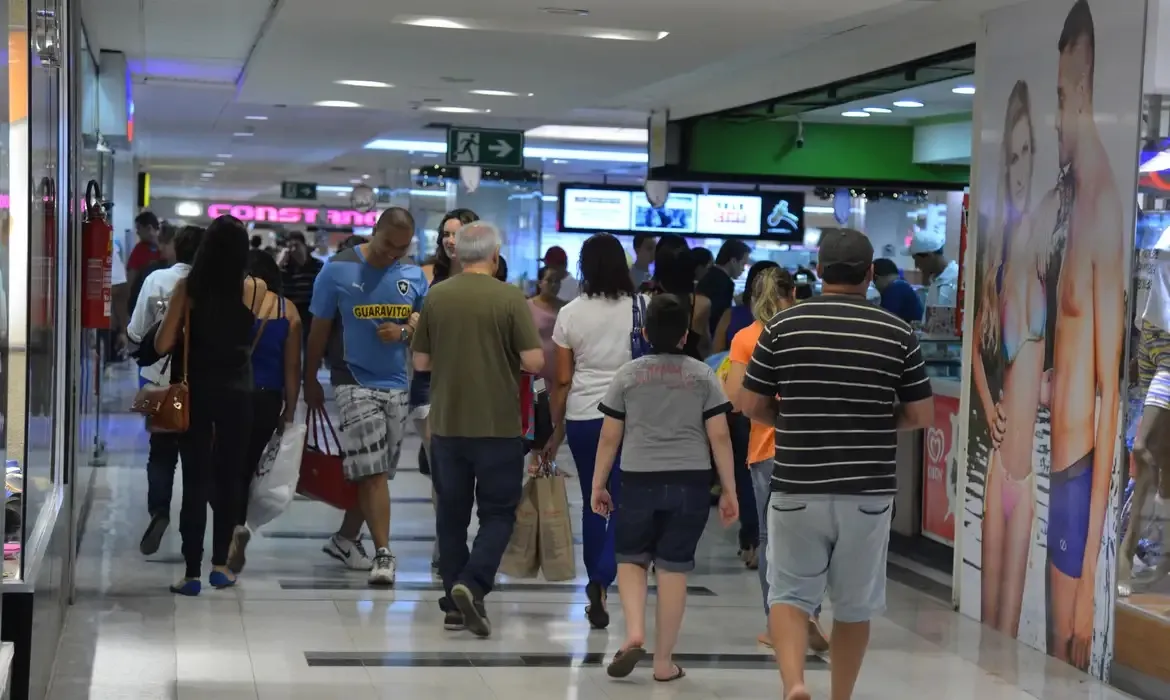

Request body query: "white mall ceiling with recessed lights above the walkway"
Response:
[83, 0, 1013, 199]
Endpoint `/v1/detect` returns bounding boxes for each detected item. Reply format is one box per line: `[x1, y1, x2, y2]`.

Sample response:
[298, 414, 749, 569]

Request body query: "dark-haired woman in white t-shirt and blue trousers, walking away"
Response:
[544, 233, 641, 629]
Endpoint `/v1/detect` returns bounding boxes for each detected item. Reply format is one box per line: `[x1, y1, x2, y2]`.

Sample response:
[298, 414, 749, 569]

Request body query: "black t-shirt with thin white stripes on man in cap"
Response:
[743, 295, 931, 494]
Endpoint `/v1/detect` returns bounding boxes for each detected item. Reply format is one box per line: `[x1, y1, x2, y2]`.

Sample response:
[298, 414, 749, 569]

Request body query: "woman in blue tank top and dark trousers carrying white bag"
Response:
[227, 248, 301, 574]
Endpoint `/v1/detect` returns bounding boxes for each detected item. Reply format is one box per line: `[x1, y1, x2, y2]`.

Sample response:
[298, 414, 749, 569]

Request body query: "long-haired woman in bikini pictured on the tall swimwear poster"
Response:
[972, 81, 1054, 638]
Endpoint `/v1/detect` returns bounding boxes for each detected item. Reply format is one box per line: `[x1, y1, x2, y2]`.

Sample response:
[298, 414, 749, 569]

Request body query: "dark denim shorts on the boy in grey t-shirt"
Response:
[613, 482, 711, 574]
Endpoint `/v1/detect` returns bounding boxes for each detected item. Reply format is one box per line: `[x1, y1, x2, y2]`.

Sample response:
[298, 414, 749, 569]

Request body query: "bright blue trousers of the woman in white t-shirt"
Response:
[565, 418, 621, 588]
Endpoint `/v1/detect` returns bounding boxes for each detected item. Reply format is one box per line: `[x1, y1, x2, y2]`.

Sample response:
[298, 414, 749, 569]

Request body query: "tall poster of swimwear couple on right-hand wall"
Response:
[958, 0, 1145, 678]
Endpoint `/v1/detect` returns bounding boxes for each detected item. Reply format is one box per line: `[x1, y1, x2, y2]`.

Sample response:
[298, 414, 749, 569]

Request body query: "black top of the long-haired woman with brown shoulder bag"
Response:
[171, 279, 256, 391]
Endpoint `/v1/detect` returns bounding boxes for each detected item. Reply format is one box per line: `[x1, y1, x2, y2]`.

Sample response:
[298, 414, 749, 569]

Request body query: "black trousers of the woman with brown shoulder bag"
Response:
[179, 386, 253, 578]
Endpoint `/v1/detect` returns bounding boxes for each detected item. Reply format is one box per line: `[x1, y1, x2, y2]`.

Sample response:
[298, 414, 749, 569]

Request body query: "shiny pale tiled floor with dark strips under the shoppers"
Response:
[50, 381, 1141, 700]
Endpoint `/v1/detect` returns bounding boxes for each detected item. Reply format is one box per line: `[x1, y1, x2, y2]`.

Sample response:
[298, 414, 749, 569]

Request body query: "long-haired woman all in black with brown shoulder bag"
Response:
[154, 215, 268, 596]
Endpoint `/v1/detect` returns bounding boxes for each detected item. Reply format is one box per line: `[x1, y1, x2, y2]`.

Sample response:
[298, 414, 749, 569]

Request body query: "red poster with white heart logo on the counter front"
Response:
[922, 394, 958, 544]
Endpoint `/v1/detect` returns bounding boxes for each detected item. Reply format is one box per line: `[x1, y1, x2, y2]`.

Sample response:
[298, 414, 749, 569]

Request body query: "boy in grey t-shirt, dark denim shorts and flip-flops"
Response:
[590, 294, 738, 681]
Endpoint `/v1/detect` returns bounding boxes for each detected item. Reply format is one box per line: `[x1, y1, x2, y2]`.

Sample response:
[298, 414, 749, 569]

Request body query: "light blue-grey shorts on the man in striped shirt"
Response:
[768, 493, 894, 623]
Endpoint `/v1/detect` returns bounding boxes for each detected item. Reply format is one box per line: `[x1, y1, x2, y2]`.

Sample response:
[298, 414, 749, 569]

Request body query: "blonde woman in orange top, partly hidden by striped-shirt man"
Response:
[724, 267, 828, 652]
